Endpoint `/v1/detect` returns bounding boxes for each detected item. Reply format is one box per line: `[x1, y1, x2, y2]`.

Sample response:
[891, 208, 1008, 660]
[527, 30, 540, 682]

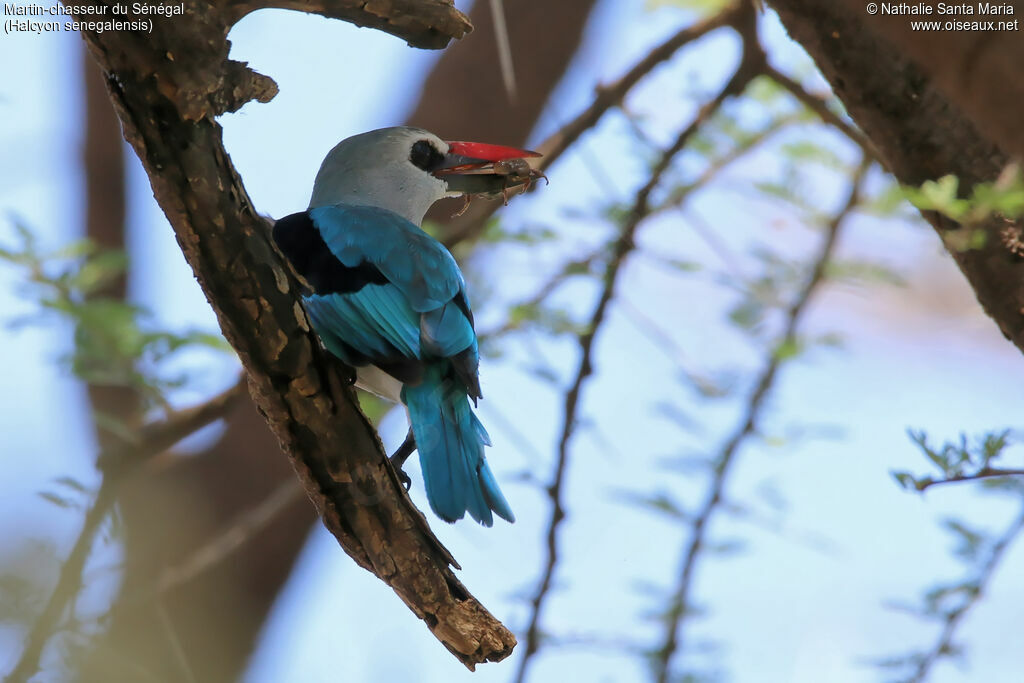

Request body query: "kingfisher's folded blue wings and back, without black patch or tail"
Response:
[305, 204, 479, 396]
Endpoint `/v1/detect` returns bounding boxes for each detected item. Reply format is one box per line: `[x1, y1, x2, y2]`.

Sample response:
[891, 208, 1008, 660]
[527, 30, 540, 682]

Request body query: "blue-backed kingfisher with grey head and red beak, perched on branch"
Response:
[273, 127, 542, 526]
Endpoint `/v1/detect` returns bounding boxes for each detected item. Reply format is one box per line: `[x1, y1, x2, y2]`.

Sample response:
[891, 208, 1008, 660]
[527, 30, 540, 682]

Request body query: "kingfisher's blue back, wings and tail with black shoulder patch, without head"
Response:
[273, 204, 515, 526]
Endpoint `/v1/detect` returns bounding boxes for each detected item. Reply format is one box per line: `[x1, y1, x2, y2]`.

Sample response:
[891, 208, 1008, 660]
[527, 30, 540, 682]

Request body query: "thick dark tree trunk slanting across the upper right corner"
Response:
[771, 0, 1024, 358]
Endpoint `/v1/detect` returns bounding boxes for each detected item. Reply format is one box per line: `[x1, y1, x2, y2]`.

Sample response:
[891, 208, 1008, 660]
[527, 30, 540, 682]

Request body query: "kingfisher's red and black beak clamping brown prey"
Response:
[431, 142, 544, 199]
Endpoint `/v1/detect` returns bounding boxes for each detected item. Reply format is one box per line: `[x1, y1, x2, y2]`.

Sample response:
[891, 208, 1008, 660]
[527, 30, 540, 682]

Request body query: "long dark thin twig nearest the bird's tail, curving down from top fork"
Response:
[515, 49, 755, 683]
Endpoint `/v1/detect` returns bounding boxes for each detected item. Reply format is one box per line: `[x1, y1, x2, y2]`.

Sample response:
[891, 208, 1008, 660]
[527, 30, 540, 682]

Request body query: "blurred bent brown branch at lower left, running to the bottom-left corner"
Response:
[5, 380, 245, 683]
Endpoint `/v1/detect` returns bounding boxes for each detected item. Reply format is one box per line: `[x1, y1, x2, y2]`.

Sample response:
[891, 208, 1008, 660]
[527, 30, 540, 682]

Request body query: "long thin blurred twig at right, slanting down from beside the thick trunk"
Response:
[654, 157, 870, 683]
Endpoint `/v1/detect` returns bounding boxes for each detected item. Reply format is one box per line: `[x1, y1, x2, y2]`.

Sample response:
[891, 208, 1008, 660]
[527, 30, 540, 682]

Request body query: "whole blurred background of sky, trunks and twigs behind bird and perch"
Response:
[0, 0, 1024, 683]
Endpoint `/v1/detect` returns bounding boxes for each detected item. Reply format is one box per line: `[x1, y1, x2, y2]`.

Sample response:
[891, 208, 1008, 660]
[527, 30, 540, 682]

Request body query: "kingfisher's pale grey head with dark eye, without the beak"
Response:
[309, 126, 449, 225]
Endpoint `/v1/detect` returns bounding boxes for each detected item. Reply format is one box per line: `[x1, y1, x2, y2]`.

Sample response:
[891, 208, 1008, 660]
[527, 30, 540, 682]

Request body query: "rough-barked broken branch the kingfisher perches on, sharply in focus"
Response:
[69, 0, 515, 669]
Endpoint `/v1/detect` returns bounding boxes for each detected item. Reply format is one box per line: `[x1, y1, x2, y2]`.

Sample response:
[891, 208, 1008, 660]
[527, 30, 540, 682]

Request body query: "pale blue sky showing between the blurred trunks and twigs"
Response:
[0, 2, 1024, 683]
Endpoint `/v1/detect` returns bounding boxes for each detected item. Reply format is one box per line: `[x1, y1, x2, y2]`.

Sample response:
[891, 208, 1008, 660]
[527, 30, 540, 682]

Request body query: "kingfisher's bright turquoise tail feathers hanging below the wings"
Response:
[401, 364, 515, 526]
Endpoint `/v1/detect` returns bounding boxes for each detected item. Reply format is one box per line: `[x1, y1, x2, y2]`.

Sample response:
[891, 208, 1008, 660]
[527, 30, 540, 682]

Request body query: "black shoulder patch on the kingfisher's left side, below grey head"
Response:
[273, 211, 387, 294]
